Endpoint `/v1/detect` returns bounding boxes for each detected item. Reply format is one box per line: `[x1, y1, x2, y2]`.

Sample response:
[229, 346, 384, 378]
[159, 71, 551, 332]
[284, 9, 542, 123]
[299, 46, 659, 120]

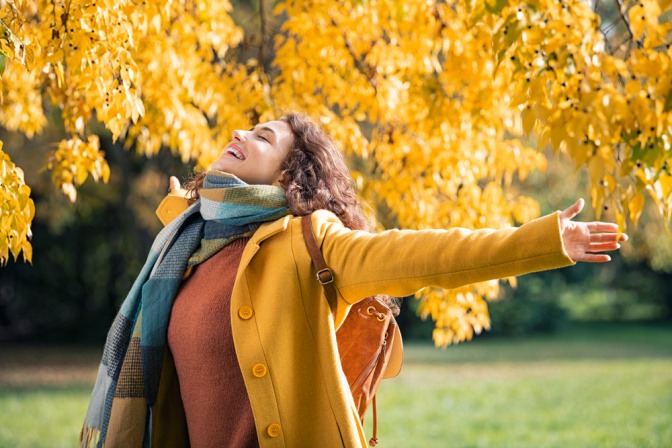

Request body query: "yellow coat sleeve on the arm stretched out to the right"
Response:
[313, 211, 574, 303]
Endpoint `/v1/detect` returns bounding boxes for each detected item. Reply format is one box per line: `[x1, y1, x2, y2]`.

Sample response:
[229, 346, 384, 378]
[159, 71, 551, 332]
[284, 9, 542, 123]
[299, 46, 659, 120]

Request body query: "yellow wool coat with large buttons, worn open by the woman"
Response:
[155, 197, 573, 448]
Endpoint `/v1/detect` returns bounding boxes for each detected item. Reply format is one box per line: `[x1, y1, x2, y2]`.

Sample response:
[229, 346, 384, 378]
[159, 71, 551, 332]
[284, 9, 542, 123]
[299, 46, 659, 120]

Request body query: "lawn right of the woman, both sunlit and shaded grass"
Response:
[367, 325, 672, 448]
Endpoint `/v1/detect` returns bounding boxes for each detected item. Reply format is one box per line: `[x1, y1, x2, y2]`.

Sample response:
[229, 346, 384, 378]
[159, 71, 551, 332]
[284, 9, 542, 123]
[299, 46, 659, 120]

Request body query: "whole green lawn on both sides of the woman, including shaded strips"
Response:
[0, 325, 672, 448]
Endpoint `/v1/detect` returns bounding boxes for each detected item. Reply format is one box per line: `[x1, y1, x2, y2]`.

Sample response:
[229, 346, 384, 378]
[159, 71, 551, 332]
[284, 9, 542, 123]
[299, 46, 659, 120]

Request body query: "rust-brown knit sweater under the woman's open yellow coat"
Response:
[168, 238, 259, 448]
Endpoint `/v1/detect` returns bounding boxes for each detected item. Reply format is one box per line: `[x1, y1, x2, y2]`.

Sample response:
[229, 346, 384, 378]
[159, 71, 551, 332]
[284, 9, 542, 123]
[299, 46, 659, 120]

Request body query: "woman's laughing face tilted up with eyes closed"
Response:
[210, 121, 294, 186]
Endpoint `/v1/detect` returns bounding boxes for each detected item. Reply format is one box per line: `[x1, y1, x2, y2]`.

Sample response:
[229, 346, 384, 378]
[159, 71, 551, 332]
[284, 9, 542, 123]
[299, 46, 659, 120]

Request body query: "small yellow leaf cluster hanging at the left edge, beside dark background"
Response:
[0, 141, 35, 266]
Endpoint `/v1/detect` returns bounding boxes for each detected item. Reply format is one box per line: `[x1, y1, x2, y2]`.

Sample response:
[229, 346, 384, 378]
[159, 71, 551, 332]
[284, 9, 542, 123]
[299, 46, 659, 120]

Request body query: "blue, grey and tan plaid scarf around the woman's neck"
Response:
[80, 171, 289, 447]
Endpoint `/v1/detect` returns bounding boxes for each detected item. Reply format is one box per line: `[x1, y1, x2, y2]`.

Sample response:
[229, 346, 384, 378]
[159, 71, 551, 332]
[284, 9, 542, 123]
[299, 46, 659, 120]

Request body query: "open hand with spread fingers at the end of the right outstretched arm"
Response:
[560, 199, 628, 263]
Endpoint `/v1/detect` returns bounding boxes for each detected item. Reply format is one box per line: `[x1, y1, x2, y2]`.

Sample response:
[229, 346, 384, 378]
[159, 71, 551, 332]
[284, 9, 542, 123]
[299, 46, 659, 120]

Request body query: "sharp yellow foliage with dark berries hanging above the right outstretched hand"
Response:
[498, 0, 672, 229]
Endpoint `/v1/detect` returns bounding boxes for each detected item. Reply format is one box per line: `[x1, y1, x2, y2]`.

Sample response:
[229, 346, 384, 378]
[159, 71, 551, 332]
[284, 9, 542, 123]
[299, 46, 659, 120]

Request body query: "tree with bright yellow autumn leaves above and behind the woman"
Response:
[0, 0, 672, 345]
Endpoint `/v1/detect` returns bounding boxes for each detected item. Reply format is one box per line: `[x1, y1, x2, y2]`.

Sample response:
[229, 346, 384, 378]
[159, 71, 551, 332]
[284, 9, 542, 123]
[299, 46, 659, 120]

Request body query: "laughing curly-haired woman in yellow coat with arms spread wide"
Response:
[82, 114, 627, 447]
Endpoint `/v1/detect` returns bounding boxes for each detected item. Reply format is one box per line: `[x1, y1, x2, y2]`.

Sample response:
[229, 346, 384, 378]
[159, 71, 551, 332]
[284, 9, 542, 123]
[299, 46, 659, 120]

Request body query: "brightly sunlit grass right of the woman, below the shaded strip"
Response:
[378, 356, 672, 448]
